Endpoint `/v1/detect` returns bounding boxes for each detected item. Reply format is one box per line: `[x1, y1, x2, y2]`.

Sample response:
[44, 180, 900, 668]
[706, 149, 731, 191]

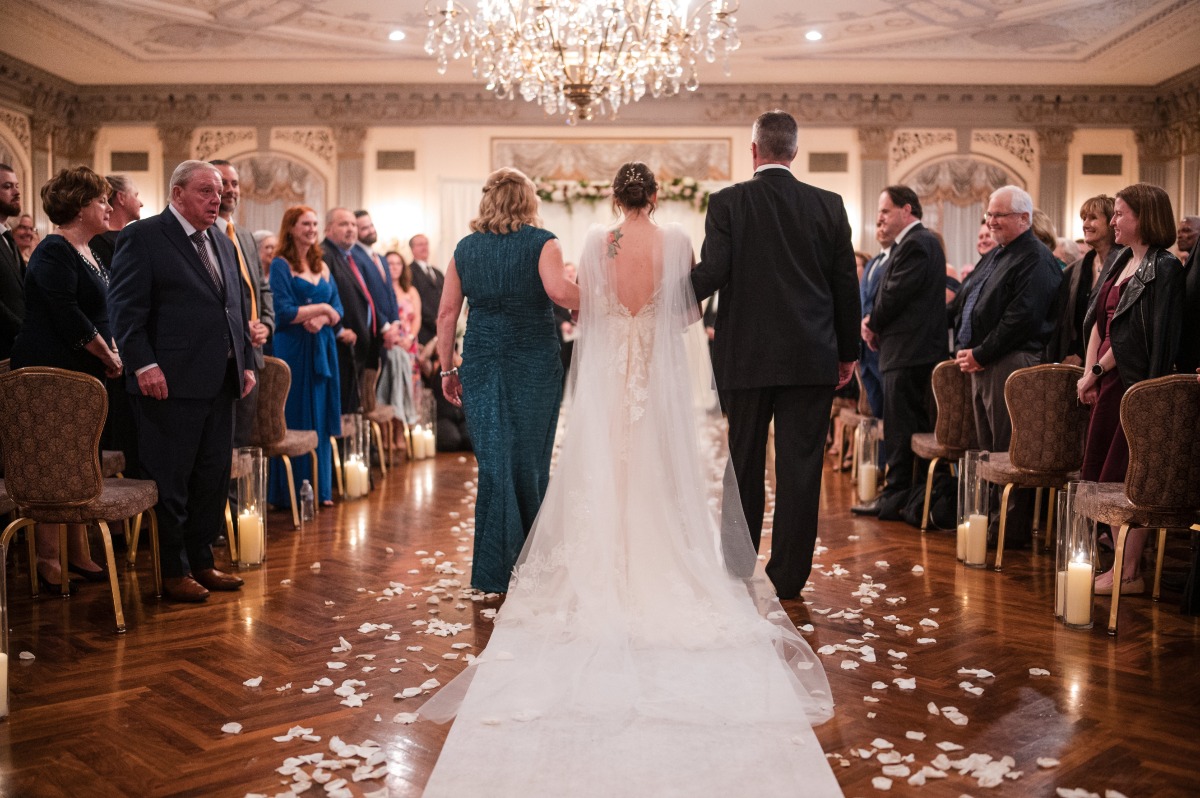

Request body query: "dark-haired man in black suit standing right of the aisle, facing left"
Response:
[851, 186, 946, 521]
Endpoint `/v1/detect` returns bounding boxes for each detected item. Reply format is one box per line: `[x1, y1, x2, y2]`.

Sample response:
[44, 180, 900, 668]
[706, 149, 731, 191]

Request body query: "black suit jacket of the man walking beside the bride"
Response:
[691, 168, 862, 390]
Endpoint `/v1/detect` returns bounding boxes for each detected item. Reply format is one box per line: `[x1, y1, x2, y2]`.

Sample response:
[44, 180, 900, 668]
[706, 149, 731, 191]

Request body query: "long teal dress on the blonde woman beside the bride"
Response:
[454, 226, 563, 593]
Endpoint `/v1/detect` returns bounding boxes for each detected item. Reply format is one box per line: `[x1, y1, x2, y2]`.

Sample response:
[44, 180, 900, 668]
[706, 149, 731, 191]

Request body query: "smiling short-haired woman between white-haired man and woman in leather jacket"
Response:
[1045, 194, 1121, 366]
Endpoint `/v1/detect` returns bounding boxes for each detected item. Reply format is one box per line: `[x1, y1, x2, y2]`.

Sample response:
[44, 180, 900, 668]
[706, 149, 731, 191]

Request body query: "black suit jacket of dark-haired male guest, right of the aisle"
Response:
[868, 223, 946, 371]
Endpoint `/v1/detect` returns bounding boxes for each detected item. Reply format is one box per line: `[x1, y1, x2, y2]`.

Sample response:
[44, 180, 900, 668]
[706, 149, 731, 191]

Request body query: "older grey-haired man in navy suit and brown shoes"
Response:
[108, 161, 256, 601]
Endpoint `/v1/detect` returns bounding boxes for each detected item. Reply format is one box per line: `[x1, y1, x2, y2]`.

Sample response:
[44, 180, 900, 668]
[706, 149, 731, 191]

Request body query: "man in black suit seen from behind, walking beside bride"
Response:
[691, 110, 862, 599]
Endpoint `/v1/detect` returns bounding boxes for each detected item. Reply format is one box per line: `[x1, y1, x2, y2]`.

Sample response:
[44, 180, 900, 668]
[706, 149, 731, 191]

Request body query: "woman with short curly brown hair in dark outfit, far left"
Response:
[12, 167, 122, 590]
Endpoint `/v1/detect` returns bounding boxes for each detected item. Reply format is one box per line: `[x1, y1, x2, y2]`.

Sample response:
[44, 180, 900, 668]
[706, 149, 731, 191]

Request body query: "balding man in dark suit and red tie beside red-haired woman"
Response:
[320, 208, 369, 413]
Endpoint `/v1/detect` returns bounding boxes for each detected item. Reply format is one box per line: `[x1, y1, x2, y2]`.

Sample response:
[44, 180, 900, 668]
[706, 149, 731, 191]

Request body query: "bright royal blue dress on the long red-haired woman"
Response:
[266, 258, 343, 508]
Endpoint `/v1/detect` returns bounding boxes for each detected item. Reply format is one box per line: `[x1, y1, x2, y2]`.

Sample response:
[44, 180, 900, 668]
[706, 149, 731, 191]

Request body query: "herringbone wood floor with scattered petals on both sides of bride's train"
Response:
[0, 454, 1200, 798]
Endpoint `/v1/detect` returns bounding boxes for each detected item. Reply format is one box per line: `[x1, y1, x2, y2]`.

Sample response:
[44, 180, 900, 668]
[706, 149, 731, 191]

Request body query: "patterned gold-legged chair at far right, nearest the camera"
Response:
[1075, 374, 1200, 635]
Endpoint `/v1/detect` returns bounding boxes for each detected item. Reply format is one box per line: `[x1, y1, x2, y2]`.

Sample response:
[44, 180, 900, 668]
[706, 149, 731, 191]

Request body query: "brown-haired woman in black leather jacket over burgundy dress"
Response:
[1078, 182, 1183, 595]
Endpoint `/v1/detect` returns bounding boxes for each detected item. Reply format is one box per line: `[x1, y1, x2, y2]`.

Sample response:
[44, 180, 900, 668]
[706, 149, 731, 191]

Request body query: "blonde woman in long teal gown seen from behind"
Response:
[438, 168, 580, 593]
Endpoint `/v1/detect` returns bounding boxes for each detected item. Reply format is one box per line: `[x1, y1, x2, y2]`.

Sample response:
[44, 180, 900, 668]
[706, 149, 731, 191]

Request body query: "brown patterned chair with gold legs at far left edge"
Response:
[0, 367, 162, 632]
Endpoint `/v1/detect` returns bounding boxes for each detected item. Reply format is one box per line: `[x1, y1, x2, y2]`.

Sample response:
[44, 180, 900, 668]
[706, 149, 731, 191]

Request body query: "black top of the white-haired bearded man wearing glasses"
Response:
[950, 229, 1062, 366]
